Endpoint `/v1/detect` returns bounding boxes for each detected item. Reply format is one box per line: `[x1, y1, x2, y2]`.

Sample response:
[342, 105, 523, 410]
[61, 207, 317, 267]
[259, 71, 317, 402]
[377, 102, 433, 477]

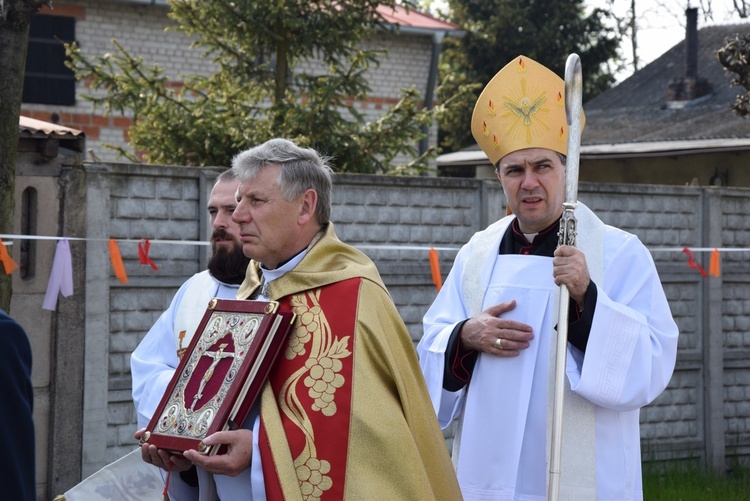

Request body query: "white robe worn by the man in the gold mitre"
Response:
[417, 205, 678, 501]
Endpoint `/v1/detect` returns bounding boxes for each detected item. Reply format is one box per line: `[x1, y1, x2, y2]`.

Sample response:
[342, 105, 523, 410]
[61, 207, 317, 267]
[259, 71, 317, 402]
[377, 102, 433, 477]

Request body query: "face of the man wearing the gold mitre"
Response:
[498, 148, 565, 233]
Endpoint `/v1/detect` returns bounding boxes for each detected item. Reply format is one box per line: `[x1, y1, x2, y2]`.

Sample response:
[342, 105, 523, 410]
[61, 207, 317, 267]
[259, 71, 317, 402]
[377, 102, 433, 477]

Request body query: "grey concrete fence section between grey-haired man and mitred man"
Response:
[332, 176, 481, 342]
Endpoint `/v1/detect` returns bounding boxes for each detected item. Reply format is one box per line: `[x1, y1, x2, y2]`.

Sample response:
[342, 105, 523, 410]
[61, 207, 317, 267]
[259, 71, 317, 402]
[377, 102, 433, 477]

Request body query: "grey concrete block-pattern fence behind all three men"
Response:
[60, 164, 750, 480]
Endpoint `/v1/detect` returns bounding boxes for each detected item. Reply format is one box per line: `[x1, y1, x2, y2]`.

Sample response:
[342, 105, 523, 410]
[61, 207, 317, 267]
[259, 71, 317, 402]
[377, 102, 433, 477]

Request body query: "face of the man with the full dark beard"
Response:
[207, 179, 249, 284]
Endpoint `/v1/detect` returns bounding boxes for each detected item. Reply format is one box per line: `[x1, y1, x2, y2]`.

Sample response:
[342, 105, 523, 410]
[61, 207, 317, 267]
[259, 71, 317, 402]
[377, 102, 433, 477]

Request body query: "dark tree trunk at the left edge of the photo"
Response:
[0, 0, 50, 311]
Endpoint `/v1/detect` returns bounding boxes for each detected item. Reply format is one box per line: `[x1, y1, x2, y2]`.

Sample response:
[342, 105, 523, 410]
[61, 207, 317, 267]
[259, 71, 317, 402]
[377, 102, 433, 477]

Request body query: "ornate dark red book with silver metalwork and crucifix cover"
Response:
[141, 298, 295, 455]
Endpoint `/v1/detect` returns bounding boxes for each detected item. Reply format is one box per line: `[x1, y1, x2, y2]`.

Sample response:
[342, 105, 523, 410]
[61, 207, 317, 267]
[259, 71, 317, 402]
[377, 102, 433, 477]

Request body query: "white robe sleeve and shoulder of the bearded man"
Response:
[130, 271, 239, 501]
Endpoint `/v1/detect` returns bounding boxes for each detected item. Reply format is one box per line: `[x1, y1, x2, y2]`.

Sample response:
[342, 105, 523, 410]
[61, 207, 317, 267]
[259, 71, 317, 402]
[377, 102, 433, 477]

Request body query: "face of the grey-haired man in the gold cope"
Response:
[232, 165, 309, 269]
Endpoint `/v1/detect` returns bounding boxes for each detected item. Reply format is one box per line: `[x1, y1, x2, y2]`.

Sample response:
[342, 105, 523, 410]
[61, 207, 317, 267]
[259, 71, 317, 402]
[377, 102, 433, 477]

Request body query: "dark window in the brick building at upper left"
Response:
[23, 15, 76, 106]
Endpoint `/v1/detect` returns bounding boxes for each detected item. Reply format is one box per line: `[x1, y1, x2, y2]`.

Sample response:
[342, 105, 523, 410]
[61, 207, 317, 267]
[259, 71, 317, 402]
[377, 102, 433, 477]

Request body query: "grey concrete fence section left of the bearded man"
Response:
[84, 164, 217, 464]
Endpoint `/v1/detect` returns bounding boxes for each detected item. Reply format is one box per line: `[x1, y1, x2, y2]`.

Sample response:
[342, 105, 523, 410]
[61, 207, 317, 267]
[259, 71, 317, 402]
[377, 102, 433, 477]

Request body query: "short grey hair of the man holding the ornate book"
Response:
[232, 138, 333, 225]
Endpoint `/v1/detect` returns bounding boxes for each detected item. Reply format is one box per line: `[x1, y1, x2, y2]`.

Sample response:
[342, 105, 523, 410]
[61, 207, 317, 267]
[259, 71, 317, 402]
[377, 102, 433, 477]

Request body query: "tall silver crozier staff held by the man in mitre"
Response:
[547, 54, 583, 501]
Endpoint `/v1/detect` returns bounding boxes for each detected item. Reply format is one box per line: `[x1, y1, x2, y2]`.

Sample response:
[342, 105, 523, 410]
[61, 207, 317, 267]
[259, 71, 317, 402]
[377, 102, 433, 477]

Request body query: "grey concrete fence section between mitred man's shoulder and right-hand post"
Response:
[579, 184, 708, 459]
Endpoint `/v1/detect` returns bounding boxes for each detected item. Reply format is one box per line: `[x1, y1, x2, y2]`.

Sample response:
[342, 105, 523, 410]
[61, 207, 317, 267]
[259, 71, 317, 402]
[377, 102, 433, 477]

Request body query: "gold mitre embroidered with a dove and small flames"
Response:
[471, 56, 586, 165]
